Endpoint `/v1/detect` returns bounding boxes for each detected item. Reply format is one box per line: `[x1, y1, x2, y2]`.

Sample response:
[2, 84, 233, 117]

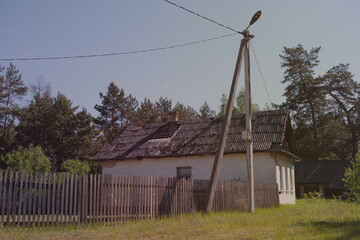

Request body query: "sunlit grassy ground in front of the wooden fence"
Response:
[0, 199, 360, 240]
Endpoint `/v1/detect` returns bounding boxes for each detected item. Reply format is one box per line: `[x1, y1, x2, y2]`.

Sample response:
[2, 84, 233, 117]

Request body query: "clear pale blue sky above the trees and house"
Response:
[0, 0, 360, 116]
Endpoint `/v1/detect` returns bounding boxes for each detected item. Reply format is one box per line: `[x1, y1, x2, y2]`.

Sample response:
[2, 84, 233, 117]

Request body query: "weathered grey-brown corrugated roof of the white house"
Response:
[94, 110, 296, 160]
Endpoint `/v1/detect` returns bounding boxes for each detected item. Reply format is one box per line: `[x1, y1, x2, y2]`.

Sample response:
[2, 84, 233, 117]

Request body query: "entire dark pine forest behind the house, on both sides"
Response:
[0, 44, 360, 172]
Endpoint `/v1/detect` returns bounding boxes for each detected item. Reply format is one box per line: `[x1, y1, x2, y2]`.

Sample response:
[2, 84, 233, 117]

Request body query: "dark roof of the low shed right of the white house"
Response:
[295, 160, 349, 188]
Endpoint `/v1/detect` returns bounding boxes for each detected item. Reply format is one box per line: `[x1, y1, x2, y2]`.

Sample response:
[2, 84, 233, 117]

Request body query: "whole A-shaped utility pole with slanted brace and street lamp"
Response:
[205, 11, 261, 213]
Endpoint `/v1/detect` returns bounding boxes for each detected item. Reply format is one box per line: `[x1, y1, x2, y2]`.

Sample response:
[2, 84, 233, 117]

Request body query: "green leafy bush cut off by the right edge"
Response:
[343, 142, 360, 202]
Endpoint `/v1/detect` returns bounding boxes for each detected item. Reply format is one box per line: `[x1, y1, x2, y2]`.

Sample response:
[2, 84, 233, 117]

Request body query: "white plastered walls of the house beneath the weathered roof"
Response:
[103, 153, 295, 204]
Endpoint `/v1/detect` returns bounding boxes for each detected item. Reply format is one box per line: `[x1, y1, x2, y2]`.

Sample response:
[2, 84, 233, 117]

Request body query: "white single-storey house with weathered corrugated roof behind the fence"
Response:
[94, 110, 299, 204]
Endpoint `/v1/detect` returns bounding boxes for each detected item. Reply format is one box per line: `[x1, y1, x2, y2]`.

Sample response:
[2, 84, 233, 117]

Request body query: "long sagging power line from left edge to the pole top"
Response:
[0, 33, 238, 61]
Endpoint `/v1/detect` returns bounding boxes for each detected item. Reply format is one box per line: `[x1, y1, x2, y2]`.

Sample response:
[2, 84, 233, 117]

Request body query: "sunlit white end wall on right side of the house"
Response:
[275, 154, 296, 204]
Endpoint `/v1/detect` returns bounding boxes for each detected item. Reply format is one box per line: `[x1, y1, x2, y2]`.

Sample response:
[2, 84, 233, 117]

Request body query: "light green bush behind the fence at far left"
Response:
[1, 145, 51, 172]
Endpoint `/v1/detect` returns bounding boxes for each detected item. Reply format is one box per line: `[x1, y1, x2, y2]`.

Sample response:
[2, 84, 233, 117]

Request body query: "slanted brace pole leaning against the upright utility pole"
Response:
[205, 38, 248, 213]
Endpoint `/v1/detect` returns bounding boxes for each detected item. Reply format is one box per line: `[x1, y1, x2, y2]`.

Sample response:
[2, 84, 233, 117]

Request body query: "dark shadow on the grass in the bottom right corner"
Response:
[311, 220, 360, 240]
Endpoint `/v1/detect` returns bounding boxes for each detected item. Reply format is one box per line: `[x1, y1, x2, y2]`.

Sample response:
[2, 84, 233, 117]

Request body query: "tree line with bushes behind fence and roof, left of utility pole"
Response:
[0, 63, 258, 173]
